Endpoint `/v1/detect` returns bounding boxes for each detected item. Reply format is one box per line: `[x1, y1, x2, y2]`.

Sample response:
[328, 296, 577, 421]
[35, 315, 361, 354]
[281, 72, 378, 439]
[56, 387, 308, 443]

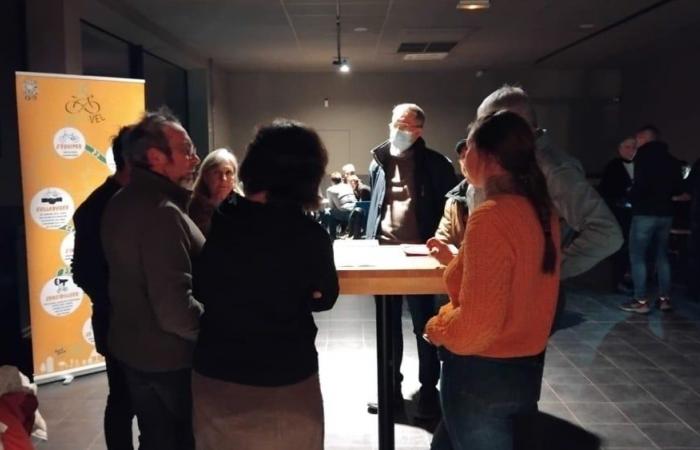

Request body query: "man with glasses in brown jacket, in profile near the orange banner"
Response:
[101, 112, 204, 450]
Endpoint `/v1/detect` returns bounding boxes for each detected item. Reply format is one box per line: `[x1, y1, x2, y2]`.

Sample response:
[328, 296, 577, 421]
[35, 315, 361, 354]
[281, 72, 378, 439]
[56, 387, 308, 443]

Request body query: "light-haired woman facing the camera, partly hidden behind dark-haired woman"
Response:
[189, 148, 238, 236]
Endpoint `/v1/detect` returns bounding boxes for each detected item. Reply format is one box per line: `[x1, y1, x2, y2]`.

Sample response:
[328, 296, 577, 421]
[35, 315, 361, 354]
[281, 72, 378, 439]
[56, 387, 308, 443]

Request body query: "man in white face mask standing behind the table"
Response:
[366, 103, 457, 419]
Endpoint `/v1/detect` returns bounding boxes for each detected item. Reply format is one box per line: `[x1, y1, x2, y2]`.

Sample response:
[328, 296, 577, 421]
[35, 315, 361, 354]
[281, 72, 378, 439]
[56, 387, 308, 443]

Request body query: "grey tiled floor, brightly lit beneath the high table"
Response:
[38, 290, 700, 450]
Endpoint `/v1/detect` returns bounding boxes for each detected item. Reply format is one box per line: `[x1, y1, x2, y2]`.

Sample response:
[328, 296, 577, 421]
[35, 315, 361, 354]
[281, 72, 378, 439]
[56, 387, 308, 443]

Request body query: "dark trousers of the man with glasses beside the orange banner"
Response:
[122, 364, 194, 450]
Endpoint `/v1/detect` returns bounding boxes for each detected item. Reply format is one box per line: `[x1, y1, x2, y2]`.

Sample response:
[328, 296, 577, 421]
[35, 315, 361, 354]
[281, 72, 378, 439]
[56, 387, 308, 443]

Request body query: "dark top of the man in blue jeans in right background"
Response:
[630, 141, 683, 216]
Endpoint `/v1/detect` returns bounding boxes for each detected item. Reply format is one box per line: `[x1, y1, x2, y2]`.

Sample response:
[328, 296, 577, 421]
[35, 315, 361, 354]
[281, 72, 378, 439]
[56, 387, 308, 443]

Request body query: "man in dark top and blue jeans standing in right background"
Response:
[620, 125, 682, 314]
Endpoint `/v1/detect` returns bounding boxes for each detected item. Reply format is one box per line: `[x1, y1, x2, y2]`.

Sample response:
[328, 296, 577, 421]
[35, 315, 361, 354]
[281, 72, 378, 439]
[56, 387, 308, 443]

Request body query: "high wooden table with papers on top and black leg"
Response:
[334, 241, 445, 450]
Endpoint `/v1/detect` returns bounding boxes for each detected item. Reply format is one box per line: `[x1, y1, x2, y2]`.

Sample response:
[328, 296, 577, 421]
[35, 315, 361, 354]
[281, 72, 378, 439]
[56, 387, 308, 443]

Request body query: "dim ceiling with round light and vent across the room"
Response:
[108, 0, 700, 72]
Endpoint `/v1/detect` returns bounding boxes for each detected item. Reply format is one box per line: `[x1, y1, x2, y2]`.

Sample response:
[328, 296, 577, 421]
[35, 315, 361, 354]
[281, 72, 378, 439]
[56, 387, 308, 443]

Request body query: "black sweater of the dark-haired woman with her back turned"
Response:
[194, 195, 338, 386]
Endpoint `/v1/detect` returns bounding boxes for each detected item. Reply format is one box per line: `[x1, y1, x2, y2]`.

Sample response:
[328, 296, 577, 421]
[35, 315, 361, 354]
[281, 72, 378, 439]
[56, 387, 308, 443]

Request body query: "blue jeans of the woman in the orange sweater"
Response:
[430, 349, 544, 450]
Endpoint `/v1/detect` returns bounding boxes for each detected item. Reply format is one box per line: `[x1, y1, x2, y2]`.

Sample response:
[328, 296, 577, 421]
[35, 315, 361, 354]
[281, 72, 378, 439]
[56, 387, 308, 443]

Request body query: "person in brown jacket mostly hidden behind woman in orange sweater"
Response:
[435, 139, 469, 248]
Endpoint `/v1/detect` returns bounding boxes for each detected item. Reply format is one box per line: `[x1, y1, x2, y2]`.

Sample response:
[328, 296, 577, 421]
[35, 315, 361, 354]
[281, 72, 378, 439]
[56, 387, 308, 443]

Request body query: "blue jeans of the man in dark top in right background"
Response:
[629, 216, 673, 299]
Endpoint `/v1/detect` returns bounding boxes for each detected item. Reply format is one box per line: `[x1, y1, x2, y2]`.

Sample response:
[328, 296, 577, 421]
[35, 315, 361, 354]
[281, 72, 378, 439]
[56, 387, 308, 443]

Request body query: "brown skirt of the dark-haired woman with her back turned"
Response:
[192, 371, 323, 450]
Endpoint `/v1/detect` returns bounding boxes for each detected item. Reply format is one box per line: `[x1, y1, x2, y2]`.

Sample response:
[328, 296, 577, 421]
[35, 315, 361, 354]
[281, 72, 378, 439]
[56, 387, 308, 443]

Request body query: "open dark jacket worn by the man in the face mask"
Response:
[366, 138, 457, 241]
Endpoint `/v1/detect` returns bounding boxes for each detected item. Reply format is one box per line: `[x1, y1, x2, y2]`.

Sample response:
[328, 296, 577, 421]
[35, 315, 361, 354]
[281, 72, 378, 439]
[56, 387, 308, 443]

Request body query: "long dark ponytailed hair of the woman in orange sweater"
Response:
[469, 111, 557, 273]
